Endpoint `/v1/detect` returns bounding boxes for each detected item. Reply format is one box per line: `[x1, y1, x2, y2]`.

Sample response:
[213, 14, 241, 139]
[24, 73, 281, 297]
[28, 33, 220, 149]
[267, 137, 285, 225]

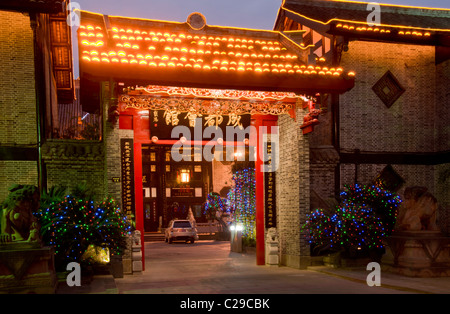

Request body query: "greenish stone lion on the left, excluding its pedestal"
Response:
[0, 185, 40, 243]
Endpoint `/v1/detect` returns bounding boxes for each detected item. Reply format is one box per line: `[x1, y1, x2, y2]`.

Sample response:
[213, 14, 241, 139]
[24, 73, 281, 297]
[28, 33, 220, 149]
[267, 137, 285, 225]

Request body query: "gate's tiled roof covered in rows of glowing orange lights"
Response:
[78, 12, 354, 92]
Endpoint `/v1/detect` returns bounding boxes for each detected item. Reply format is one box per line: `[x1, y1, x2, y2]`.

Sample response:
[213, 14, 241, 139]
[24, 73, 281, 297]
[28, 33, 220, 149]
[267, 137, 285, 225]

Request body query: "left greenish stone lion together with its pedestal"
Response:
[0, 185, 57, 294]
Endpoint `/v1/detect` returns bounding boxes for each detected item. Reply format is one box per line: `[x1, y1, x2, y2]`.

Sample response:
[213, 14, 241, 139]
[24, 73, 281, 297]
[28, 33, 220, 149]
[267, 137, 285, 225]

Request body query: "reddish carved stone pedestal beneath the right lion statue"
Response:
[383, 231, 450, 277]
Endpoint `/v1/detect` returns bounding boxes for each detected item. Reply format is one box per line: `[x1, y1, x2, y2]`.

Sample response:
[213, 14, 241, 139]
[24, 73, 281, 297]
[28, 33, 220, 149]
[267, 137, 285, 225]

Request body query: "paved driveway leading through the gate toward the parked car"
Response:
[115, 241, 412, 294]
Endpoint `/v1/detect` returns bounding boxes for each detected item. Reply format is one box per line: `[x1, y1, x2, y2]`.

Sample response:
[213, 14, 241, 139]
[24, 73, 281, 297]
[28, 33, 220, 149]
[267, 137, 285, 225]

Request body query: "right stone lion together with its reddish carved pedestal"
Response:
[382, 186, 450, 277]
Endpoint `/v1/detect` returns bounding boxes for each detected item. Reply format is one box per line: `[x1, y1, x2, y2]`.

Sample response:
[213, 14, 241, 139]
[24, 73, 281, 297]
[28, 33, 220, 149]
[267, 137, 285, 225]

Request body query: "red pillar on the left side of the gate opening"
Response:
[134, 142, 145, 270]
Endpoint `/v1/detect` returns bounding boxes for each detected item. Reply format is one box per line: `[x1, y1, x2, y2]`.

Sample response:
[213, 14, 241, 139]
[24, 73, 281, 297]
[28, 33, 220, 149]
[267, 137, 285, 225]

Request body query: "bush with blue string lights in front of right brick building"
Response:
[302, 184, 401, 257]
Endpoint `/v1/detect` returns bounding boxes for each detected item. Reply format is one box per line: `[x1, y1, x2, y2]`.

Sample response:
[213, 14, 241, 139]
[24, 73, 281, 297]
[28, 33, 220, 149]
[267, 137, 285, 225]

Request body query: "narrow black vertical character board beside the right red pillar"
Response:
[264, 136, 277, 228]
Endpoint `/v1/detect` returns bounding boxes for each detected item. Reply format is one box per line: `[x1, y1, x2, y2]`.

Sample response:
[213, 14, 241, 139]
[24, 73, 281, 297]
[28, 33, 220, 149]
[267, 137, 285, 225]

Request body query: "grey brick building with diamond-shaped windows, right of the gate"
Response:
[274, 0, 450, 268]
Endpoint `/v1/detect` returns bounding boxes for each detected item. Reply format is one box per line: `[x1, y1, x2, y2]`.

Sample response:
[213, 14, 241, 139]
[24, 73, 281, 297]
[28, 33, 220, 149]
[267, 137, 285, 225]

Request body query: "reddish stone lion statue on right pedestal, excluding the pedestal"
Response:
[396, 186, 439, 231]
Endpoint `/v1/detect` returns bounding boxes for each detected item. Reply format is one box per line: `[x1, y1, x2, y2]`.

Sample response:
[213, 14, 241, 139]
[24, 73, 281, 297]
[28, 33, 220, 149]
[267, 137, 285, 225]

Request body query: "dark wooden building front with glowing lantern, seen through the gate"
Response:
[142, 145, 212, 232]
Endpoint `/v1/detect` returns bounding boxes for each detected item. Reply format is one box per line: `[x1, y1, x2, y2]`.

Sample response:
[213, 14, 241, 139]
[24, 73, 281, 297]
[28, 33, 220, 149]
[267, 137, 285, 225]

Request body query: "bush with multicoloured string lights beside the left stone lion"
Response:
[36, 188, 131, 268]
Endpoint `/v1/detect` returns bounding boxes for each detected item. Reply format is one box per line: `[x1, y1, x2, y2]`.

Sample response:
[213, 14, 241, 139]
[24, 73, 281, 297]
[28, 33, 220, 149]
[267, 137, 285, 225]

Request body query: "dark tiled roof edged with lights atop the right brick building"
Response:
[282, 0, 450, 32]
